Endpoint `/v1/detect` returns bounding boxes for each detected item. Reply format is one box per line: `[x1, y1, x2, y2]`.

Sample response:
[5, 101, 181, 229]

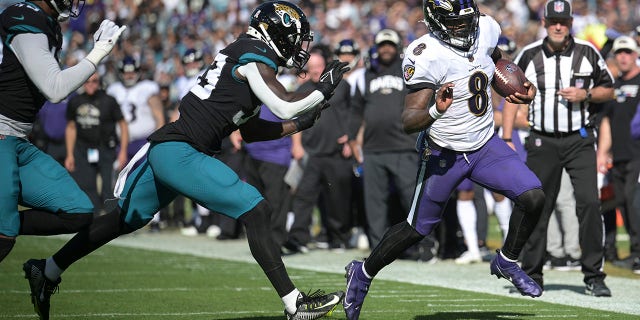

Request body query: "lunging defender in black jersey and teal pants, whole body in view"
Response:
[26, 1, 349, 319]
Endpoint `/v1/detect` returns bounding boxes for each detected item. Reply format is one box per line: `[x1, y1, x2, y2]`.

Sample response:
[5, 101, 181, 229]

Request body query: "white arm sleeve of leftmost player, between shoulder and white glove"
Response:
[9, 33, 96, 103]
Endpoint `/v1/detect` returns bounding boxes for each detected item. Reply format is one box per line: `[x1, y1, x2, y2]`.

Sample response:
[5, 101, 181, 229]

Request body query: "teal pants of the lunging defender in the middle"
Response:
[118, 141, 263, 229]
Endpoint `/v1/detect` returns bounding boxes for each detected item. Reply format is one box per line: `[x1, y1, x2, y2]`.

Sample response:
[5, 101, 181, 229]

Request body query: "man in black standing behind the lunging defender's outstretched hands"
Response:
[285, 50, 352, 252]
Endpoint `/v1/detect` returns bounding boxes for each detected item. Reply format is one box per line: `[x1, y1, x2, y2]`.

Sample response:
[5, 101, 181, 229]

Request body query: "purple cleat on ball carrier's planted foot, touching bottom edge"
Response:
[342, 260, 371, 320]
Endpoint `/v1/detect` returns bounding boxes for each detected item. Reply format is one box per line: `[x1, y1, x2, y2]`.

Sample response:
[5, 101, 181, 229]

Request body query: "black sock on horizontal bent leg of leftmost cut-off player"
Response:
[20, 209, 93, 236]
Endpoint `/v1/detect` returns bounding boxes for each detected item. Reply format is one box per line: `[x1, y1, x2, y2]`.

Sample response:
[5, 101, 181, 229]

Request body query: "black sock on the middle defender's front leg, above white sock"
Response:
[239, 200, 295, 297]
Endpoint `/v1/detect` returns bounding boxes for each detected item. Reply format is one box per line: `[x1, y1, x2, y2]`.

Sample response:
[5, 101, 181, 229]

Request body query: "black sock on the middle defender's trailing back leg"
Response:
[53, 207, 133, 270]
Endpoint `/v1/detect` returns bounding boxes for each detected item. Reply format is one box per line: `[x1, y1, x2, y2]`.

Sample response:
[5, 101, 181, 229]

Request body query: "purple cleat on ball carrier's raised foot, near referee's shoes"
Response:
[491, 250, 542, 298]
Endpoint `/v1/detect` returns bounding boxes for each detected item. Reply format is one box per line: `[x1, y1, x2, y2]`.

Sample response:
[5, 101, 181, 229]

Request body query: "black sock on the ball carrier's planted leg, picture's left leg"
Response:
[365, 221, 425, 277]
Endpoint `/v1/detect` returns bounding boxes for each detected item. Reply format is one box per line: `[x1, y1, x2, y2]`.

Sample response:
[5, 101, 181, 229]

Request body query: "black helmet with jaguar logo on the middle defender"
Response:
[247, 1, 313, 70]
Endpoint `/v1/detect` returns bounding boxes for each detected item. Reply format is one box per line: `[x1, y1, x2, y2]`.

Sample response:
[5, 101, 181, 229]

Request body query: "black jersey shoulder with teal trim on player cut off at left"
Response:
[1, 2, 57, 36]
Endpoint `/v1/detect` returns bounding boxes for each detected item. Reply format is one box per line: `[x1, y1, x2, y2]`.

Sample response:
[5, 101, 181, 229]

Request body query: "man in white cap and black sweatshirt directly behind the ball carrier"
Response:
[349, 29, 418, 248]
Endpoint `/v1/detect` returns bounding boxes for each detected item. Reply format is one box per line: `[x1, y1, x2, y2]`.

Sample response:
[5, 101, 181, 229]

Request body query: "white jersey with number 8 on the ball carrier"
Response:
[402, 15, 501, 152]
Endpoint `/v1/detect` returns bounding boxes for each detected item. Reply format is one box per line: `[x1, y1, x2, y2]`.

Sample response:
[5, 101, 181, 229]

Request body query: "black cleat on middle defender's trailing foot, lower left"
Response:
[22, 259, 62, 320]
